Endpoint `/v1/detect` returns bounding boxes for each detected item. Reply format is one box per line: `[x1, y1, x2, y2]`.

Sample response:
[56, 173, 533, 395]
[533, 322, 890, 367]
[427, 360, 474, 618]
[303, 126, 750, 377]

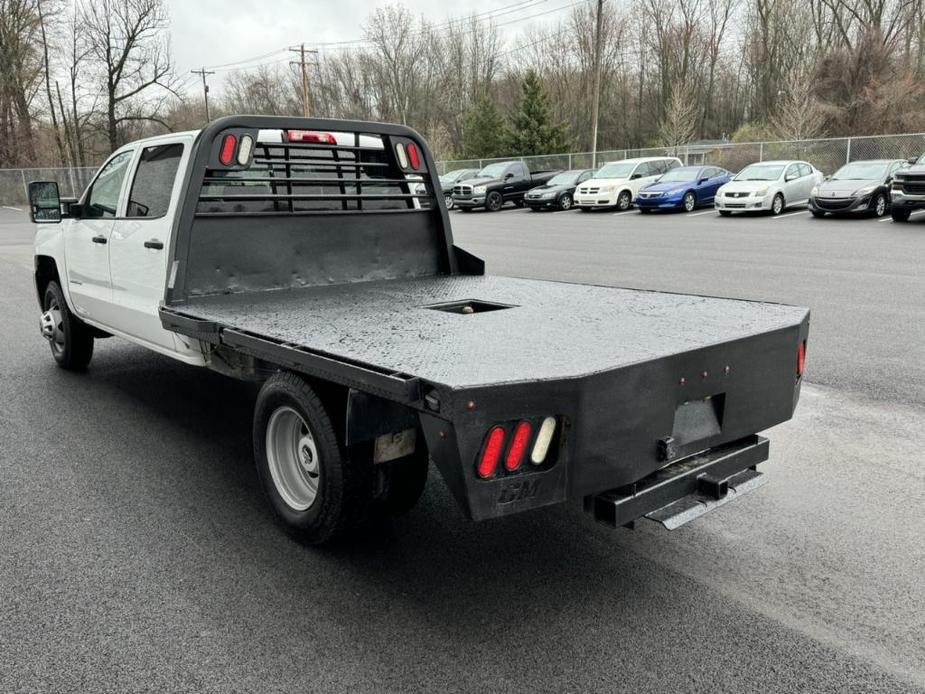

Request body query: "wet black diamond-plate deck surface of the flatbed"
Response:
[172, 276, 807, 388]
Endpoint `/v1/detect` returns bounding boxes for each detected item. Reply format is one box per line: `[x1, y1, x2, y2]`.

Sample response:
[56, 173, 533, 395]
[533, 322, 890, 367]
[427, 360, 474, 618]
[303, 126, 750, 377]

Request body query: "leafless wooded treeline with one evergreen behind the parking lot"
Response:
[0, 0, 925, 167]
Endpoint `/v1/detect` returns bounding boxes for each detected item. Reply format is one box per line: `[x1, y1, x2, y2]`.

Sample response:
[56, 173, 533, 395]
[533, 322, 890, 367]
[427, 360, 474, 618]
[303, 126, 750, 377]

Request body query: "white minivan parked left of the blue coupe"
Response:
[575, 157, 681, 212]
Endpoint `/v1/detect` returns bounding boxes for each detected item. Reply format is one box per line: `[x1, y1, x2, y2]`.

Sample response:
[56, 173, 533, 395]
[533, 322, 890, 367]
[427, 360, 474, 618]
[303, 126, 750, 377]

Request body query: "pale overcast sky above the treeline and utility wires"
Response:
[166, 0, 575, 91]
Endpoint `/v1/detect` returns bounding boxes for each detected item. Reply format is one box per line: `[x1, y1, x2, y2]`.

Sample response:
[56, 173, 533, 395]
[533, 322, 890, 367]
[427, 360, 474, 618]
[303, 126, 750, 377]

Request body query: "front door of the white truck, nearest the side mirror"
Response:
[64, 150, 133, 323]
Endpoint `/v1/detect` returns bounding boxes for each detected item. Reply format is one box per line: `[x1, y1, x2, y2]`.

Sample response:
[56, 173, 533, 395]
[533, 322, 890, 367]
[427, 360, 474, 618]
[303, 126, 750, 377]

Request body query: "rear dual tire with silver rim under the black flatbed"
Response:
[254, 373, 374, 545]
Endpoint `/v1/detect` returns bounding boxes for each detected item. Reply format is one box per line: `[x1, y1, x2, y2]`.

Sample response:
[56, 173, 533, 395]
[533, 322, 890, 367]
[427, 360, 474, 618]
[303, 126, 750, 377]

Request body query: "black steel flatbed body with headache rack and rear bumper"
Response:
[161, 117, 809, 540]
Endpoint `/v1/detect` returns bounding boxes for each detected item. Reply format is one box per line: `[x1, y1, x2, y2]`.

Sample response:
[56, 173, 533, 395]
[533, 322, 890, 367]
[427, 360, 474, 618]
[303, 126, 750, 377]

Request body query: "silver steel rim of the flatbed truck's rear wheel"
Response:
[265, 405, 321, 511]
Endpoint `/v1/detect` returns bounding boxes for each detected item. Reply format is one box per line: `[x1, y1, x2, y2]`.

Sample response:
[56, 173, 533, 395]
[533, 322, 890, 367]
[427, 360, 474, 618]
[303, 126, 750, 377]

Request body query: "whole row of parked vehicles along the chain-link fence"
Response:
[441, 155, 925, 221]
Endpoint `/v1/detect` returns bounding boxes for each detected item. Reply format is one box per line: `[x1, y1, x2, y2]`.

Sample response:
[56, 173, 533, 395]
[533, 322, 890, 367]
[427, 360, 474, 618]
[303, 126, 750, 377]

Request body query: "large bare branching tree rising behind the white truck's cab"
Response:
[83, 0, 173, 149]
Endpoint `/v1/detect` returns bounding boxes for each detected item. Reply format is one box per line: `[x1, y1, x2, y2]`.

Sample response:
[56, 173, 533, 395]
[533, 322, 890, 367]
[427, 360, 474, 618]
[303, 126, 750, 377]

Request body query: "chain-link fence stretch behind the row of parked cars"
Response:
[437, 133, 925, 174]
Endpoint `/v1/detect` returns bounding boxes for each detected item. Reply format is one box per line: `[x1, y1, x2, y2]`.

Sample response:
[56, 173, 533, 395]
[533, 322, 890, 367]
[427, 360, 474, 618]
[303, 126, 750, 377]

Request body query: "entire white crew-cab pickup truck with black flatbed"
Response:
[29, 116, 809, 543]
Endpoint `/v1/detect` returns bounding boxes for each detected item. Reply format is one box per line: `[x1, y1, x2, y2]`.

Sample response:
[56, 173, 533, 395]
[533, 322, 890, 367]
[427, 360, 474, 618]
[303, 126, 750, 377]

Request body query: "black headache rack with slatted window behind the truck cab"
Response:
[165, 116, 470, 308]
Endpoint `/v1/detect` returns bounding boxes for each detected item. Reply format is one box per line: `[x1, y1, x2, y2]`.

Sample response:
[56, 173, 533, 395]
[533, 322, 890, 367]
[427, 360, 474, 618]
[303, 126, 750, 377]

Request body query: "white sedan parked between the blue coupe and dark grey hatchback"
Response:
[714, 161, 825, 217]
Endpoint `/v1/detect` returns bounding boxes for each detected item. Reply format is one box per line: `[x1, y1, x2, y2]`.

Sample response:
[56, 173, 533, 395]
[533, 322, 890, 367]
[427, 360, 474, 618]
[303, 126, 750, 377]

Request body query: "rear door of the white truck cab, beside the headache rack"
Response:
[109, 142, 188, 350]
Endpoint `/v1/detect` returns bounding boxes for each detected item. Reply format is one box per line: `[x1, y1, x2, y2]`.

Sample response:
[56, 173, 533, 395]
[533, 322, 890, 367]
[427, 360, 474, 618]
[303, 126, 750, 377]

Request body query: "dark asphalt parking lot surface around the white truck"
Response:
[0, 209, 925, 693]
